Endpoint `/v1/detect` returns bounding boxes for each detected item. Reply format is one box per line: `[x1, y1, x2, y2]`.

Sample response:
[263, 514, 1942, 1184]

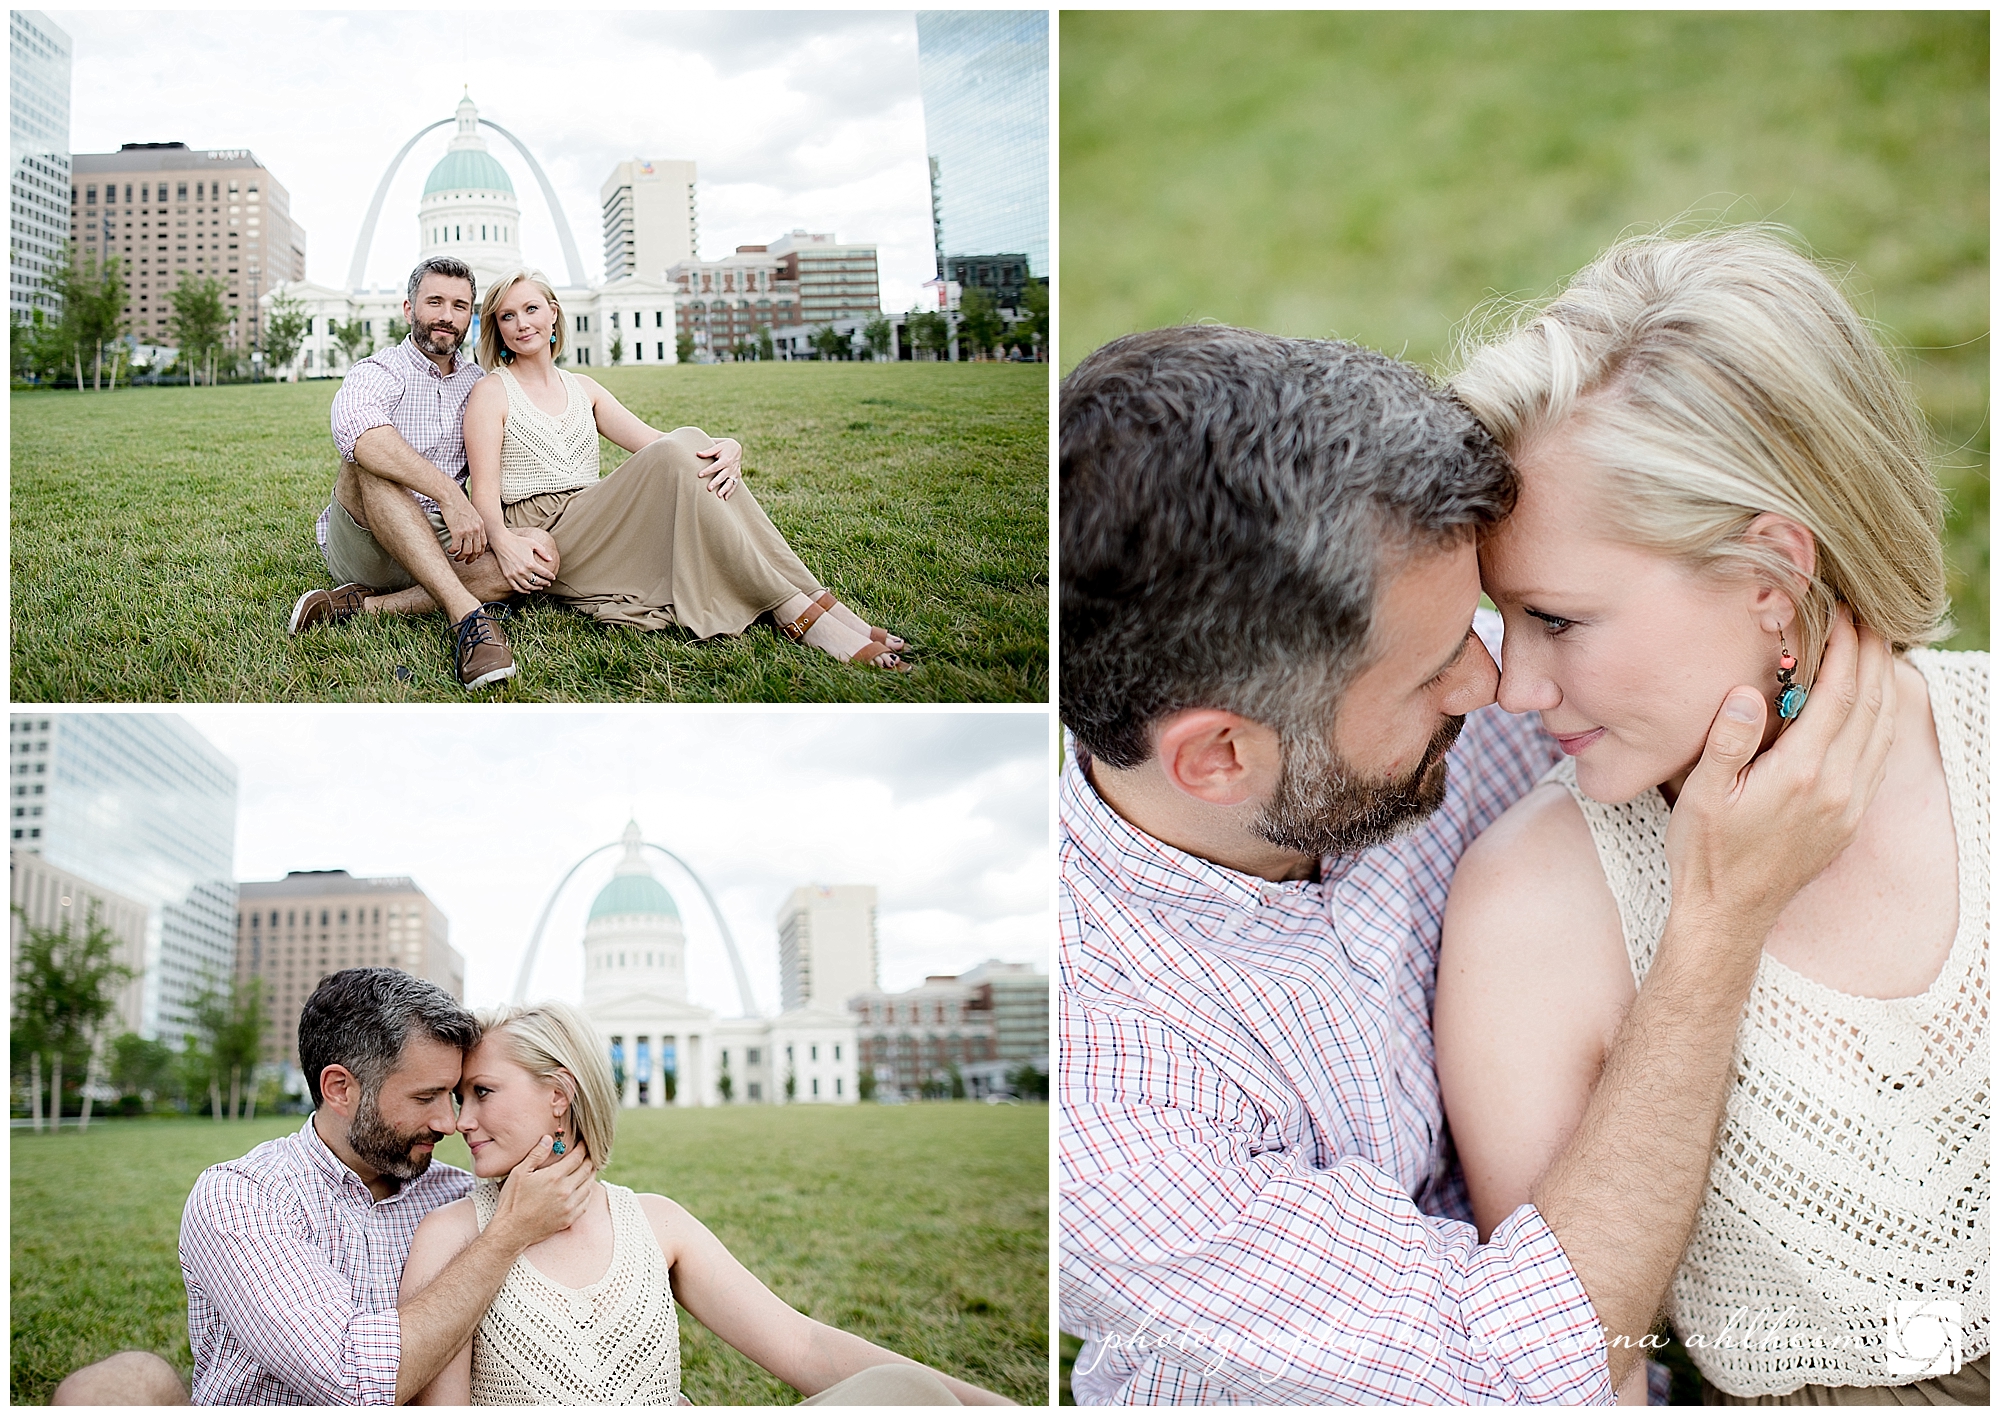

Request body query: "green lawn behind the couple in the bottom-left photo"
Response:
[10, 1102, 1048, 1406]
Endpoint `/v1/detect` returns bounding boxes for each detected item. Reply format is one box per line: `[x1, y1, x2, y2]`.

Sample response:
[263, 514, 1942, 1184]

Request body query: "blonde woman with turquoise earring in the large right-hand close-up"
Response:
[1436, 230, 1988, 1404]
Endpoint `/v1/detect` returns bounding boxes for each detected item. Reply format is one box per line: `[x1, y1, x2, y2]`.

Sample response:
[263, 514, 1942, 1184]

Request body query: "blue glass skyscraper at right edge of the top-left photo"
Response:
[916, 10, 1048, 280]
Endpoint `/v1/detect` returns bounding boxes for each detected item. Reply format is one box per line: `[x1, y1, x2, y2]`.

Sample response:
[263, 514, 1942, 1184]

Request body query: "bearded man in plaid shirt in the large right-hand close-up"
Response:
[1058, 328, 1892, 1404]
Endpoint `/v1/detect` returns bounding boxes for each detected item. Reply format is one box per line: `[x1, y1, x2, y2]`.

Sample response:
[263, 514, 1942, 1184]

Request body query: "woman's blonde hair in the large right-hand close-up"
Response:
[1450, 226, 1950, 680]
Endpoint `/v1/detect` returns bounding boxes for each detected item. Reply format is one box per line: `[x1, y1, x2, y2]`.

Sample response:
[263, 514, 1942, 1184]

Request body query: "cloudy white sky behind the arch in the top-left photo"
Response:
[48, 4, 952, 310]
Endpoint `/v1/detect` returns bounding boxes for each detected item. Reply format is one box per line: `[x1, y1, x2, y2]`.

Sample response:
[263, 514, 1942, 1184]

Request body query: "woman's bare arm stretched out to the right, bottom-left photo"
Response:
[640, 1194, 1014, 1406]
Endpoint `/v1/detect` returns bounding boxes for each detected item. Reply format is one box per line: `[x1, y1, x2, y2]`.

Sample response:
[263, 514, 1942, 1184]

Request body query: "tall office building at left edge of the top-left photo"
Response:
[8, 10, 70, 316]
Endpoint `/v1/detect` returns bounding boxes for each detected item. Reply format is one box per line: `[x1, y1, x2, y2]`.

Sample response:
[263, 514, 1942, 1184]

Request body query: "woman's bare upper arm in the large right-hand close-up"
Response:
[1434, 784, 1646, 1406]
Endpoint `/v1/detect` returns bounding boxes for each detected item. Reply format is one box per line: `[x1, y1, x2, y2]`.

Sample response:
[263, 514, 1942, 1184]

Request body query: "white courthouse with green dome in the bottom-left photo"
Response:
[584, 822, 874, 1106]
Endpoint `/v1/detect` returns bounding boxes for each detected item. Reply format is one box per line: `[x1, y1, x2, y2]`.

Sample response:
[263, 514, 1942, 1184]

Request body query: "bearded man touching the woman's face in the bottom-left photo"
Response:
[58, 968, 592, 1406]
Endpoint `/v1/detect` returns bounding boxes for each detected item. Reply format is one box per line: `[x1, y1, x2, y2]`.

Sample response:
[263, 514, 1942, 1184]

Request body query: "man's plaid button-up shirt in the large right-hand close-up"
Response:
[1058, 652, 1614, 1406]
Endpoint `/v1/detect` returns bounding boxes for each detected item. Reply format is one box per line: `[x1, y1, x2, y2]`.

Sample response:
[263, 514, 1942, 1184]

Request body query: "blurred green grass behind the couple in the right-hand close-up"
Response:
[1060, 10, 1990, 648]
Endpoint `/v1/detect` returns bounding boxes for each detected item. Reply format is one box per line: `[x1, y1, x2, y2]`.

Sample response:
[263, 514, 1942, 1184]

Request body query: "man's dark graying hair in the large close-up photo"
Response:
[1060, 326, 1516, 768]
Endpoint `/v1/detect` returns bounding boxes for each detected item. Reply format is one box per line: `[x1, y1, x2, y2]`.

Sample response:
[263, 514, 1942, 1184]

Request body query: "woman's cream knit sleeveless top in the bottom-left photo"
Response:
[472, 1180, 680, 1406]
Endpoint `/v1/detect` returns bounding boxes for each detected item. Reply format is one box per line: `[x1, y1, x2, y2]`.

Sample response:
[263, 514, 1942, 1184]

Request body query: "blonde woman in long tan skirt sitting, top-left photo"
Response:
[464, 270, 908, 670]
